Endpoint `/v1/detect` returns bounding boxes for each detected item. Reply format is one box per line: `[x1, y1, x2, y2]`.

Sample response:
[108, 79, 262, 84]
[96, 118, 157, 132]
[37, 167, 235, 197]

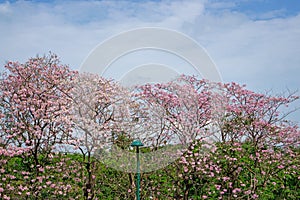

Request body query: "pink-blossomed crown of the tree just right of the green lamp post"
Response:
[136, 76, 214, 149]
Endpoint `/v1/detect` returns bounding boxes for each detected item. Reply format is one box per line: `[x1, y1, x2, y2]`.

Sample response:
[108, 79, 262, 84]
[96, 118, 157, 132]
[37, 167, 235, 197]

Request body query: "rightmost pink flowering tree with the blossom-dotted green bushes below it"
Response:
[175, 80, 300, 199]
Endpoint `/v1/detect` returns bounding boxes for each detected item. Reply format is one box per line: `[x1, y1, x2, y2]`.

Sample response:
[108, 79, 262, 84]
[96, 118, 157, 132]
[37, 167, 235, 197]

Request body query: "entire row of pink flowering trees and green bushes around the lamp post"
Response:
[0, 54, 300, 200]
